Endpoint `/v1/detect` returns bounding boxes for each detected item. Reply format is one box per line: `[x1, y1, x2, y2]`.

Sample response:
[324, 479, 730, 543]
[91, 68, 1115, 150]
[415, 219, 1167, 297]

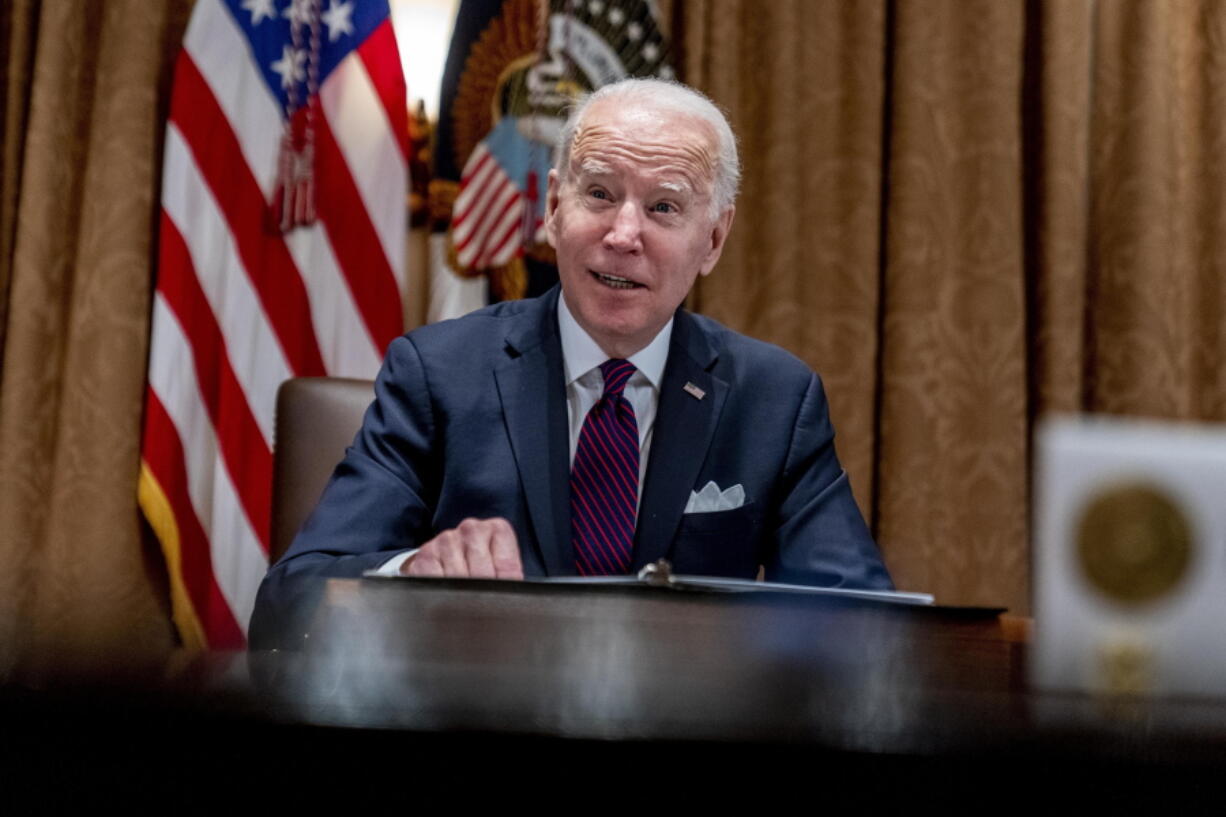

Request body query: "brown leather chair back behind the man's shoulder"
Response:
[268, 378, 374, 562]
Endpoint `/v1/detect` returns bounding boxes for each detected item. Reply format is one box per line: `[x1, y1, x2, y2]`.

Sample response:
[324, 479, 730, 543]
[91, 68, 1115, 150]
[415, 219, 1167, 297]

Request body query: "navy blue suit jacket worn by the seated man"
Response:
[253, 288, 891, 643]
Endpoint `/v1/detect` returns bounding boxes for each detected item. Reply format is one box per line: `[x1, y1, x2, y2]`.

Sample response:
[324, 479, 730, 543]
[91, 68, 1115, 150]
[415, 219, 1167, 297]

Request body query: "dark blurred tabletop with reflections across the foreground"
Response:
[0, 580, 1226, 813]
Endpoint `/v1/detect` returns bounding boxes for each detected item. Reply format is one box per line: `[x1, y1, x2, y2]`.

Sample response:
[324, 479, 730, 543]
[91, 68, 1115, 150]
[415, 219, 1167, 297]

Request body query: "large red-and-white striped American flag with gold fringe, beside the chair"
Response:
[140, 0, 408, 648]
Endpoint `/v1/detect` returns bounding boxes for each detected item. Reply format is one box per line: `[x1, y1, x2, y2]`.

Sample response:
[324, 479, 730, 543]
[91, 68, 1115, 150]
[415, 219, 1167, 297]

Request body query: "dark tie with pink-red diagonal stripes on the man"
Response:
[570, 359, 639, 575]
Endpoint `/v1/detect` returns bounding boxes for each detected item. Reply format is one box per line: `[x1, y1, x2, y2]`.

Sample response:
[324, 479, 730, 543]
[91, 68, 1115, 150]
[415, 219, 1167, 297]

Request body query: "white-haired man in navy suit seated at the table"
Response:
[253, 80, 891, 629]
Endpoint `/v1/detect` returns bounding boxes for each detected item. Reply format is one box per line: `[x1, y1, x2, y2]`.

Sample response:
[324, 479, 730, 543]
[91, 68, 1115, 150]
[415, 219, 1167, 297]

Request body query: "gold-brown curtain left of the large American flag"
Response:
[0, 0, 188, 677]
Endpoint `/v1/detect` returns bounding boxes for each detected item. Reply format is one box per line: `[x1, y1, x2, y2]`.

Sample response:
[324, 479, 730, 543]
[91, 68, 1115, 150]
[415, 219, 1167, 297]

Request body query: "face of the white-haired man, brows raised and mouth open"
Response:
[546, 99, 733, 357]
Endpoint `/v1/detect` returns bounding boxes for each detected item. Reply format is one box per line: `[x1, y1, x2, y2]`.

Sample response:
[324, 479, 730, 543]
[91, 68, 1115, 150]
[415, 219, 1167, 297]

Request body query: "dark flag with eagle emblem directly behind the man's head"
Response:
[430, 0, 673, 299]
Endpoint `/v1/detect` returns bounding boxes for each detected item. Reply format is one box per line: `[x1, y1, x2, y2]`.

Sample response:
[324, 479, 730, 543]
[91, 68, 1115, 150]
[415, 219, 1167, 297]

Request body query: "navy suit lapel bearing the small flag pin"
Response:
[631, 312, 728, 570]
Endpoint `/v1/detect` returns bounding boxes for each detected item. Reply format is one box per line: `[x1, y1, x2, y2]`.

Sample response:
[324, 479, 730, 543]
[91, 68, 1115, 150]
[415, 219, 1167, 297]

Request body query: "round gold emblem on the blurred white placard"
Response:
[1076, 483, 1192, 606]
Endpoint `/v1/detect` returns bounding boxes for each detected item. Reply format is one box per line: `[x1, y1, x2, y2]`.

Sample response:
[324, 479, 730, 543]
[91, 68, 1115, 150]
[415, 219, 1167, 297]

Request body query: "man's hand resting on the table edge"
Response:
[400, 518, 524, 579]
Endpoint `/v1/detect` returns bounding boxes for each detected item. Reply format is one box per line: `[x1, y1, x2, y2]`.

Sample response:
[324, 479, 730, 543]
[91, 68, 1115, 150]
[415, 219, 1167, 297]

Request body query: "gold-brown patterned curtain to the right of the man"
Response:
[674, 0, 1226, 612]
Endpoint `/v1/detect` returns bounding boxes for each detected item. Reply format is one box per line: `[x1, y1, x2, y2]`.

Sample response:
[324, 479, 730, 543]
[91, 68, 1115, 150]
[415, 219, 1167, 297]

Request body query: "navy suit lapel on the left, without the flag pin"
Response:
[494, 288, 575, 575]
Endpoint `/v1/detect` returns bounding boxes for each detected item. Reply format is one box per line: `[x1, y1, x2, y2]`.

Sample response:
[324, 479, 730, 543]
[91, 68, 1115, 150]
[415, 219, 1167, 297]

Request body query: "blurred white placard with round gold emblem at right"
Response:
[1030, 418, 1226, 696]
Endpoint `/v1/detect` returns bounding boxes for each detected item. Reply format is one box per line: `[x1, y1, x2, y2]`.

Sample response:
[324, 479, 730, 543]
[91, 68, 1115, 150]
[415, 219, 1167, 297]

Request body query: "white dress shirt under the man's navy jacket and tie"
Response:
[376, 293, 673, 575]
